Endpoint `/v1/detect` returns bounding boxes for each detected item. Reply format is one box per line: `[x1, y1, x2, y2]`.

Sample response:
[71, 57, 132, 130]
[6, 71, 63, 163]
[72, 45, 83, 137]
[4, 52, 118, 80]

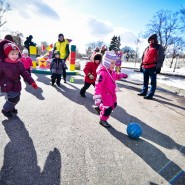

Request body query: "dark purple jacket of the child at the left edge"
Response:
[0, 61, 35, 92]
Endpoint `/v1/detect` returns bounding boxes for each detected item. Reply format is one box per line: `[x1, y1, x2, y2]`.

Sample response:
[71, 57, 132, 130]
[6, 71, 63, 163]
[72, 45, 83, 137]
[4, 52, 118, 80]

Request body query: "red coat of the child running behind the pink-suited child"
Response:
[83, 61, 99, 84]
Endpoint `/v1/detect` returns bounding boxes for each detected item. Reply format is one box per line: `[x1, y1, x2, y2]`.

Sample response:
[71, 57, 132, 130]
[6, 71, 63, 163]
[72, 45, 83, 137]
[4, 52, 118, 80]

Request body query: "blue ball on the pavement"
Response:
[127, 123, 142, 139]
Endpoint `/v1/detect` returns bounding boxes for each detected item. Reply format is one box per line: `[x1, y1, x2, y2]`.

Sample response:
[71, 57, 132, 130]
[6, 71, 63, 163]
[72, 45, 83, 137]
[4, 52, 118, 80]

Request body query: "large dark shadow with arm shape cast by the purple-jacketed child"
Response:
[0, 117, 61, 185]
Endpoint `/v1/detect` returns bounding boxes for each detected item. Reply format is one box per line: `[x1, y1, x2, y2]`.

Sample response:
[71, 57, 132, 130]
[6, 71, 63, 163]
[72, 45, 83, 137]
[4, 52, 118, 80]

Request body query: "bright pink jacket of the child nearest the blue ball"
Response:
[94, 65, 125, 107]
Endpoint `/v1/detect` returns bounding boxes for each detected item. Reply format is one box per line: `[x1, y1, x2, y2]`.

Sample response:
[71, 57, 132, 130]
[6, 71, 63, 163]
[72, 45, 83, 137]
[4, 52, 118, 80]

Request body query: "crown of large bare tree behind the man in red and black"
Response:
[145, 10, 181, 50]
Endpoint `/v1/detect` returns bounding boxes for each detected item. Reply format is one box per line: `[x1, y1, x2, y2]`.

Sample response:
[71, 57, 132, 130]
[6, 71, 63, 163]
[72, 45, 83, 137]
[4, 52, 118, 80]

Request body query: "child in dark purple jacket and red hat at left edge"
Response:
[0, 39, 37, 118]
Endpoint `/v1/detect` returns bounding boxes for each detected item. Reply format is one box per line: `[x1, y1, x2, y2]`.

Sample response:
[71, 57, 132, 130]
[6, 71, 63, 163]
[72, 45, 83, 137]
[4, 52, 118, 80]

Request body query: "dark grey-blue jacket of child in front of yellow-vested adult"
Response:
[50, 58, 65, 74]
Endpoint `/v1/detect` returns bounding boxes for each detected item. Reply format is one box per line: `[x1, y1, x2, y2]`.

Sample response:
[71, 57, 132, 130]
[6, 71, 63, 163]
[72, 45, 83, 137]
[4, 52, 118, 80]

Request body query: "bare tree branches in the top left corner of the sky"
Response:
[0, 0, 11, 27]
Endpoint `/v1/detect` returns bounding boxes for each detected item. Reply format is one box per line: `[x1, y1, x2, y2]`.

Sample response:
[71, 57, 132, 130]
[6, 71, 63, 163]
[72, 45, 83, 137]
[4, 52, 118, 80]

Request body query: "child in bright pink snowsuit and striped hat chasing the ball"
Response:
[93, 51, 128, 127]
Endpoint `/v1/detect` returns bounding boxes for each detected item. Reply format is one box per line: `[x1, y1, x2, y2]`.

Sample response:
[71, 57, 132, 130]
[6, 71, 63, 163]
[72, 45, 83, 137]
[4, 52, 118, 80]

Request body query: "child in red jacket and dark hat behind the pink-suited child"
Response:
[80, 53, 102, 98]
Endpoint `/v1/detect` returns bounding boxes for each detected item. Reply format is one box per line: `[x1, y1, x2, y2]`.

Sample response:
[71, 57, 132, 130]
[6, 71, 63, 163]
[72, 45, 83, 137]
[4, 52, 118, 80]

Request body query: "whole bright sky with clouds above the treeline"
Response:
[1, 0, 185, 51]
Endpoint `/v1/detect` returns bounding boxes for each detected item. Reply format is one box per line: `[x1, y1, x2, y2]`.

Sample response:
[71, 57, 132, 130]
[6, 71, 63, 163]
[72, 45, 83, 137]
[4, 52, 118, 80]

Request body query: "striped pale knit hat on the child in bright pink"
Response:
[102, 51, 117, 69]
